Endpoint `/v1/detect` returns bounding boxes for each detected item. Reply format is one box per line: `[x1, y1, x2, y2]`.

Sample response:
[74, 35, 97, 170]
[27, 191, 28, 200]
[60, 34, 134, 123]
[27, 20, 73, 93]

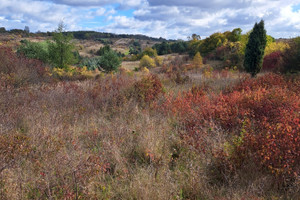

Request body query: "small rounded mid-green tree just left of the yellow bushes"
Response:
[99, 50, 121, 72]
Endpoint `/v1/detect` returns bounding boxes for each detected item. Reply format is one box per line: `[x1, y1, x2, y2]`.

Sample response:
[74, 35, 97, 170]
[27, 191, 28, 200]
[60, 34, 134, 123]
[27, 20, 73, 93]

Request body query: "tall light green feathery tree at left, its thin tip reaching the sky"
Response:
[49, 22, 76, 68]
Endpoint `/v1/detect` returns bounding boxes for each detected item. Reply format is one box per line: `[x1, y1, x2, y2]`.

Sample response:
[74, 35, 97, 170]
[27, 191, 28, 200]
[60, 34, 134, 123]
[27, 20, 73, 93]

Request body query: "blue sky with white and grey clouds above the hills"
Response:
[0, 0, 300, 40]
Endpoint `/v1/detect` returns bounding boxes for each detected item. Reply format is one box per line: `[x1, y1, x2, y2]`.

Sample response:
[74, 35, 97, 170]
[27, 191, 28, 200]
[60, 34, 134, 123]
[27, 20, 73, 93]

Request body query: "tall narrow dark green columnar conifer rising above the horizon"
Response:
[244, 20, 267, 77]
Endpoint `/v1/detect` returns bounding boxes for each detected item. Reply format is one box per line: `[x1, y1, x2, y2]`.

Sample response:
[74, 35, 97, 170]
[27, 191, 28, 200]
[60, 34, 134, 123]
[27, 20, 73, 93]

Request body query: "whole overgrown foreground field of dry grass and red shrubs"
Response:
[0, 42, 300, 200]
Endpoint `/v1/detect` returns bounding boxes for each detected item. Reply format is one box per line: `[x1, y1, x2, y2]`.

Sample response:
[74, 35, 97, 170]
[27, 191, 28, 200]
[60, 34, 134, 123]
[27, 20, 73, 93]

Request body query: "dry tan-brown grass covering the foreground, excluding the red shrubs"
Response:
[0, 46, 300, 200]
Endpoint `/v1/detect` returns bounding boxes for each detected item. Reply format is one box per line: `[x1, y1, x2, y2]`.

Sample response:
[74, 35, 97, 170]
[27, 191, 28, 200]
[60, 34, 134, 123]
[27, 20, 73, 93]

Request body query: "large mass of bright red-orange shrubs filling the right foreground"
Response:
[162, 74, 300, 178]
